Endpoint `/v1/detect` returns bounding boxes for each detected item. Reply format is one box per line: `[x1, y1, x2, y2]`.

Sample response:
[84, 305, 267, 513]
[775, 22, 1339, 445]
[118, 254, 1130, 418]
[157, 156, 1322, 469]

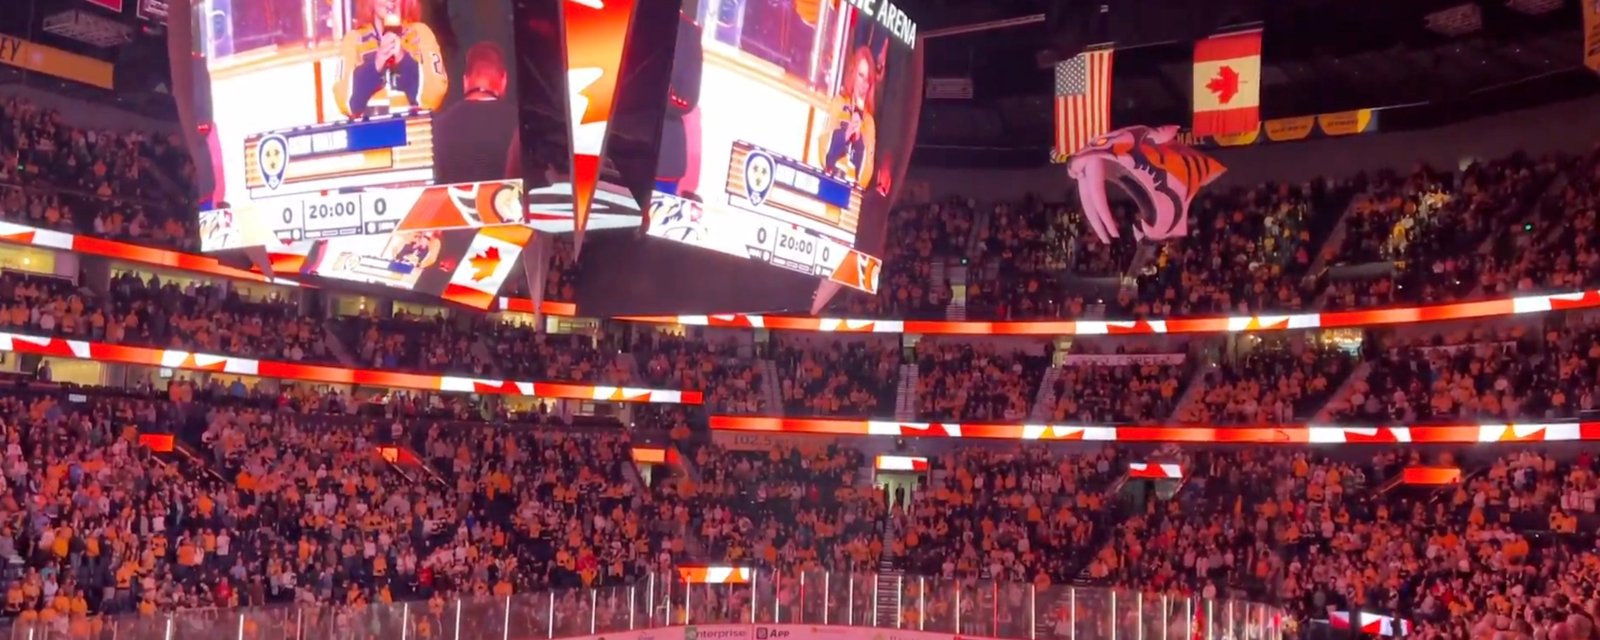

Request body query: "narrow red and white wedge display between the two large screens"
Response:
[562, 0, 634, 251]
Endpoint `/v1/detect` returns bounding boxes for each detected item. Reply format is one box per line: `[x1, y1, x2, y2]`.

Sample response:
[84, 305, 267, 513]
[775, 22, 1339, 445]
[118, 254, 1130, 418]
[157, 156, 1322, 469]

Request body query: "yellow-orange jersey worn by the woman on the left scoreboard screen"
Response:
[333, 22, 450, 118]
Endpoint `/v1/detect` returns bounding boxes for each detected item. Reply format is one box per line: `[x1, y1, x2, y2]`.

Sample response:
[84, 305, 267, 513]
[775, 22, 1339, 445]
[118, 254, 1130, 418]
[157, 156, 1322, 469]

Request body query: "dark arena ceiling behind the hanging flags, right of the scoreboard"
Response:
[907, 0, 1600, 162]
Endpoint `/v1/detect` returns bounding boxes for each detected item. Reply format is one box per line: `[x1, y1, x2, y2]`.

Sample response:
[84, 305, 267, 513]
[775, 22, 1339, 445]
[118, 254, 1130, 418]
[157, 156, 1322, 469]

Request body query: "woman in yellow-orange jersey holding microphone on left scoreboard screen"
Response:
[333, 0, 450, 118]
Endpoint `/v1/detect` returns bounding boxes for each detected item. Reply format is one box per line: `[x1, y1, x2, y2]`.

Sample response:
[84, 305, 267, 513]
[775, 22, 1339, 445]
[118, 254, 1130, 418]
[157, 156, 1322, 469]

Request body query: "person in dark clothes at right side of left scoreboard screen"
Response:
[434, 42, 517, 184]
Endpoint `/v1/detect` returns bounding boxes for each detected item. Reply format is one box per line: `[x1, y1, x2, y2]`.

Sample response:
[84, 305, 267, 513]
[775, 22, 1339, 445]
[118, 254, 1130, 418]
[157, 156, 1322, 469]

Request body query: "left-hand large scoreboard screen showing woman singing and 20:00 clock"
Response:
[194, 0, 525, 251]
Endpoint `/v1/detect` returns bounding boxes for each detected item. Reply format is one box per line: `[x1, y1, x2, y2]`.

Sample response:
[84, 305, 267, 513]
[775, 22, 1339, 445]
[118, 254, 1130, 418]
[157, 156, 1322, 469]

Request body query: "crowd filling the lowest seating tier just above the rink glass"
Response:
[9, 369, 1600, 638]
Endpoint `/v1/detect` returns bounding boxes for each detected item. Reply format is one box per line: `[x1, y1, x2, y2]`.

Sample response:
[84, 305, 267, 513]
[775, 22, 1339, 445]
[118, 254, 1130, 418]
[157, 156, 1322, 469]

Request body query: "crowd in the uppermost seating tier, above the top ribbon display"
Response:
[9, 88, 1597, 324]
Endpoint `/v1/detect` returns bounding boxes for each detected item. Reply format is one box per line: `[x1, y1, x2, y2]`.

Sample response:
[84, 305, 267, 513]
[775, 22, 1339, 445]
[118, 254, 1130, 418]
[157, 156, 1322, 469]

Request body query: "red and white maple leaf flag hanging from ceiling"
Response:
[1194, 29, 1261, 136]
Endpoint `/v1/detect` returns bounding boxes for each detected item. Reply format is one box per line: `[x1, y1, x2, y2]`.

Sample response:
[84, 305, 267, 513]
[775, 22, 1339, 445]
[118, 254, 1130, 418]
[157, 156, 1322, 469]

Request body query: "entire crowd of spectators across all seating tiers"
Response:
[21, 77, 1600, 640]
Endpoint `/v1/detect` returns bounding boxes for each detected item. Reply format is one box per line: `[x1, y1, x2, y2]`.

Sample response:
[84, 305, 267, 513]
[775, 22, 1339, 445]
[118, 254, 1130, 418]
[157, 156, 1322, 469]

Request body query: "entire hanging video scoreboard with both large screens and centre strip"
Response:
[184, 0, 923, 309]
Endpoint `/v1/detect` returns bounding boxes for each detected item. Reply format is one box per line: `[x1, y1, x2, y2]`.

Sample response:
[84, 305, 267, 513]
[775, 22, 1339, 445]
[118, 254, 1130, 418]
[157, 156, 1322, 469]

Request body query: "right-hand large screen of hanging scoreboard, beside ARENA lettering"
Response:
[636, 0, 917, 291]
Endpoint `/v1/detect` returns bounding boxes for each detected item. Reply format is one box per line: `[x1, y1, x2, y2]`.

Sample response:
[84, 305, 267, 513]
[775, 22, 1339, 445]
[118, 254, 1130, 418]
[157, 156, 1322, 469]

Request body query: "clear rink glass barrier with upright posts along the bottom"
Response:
[10, 570, 1290, 640]
